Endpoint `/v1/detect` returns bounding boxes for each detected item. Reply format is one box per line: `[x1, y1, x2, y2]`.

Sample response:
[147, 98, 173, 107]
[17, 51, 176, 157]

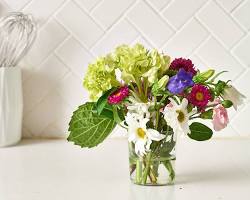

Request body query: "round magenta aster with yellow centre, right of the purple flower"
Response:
[188, 84, 211, 108]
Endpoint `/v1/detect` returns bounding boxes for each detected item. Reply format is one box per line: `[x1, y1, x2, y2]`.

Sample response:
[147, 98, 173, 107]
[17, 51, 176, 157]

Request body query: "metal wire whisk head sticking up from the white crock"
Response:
[0, 12, 37, 67]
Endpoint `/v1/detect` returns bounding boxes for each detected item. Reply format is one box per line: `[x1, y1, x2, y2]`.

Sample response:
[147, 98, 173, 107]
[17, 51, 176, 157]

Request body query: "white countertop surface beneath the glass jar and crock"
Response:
[0, 139, 250, 200]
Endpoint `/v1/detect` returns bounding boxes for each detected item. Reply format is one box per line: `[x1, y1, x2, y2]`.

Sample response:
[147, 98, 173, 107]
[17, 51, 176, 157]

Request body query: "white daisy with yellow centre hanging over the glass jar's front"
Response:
[125, 113, 165, 156]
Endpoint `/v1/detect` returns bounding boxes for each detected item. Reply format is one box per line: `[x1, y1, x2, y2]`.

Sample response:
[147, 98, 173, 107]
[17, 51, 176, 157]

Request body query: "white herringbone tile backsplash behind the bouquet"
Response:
[0, 0, 250, 137]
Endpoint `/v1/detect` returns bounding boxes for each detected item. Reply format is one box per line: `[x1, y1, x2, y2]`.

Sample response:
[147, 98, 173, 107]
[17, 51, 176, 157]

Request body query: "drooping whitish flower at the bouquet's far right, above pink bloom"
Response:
[222, 86, 246, 110]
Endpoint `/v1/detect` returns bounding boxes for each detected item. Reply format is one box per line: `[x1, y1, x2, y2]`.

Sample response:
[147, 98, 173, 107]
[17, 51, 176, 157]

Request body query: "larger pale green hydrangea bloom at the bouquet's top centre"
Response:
[113, 44, 170, 83]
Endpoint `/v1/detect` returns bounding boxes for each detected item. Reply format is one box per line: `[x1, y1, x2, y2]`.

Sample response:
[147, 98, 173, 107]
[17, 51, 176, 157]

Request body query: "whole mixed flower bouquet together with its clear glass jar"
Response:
[68, 44, 244, 185]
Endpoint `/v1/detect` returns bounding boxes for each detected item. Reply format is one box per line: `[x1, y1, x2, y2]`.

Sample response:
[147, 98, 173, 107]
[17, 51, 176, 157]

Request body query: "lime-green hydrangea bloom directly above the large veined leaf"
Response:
[83, 55, 120, 100]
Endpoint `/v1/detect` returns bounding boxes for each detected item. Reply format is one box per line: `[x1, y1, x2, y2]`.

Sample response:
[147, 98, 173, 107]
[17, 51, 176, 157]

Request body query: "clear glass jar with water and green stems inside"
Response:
[129, 132, 176, 185]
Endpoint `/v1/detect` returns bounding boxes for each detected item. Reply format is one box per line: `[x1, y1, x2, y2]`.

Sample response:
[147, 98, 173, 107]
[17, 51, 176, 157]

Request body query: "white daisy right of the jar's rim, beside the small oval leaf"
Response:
[164, 98, 193, 134]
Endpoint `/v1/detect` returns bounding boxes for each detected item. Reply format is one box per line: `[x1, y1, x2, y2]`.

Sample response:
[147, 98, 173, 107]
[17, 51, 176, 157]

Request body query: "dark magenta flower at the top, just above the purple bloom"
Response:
[169, 58, 197, 76]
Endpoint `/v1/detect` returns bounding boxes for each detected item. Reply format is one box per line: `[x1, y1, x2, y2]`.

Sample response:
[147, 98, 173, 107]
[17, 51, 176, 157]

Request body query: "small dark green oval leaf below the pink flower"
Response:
[188, 122, 213, 141]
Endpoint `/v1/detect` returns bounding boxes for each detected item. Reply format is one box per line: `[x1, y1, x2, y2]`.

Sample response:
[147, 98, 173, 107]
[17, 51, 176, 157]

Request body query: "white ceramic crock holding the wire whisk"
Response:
[0, 67, 23, 147]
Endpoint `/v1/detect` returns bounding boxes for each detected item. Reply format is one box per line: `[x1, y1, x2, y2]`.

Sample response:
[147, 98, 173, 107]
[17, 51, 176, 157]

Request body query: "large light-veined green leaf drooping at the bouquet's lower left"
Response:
[67, 102, 116, 148]
